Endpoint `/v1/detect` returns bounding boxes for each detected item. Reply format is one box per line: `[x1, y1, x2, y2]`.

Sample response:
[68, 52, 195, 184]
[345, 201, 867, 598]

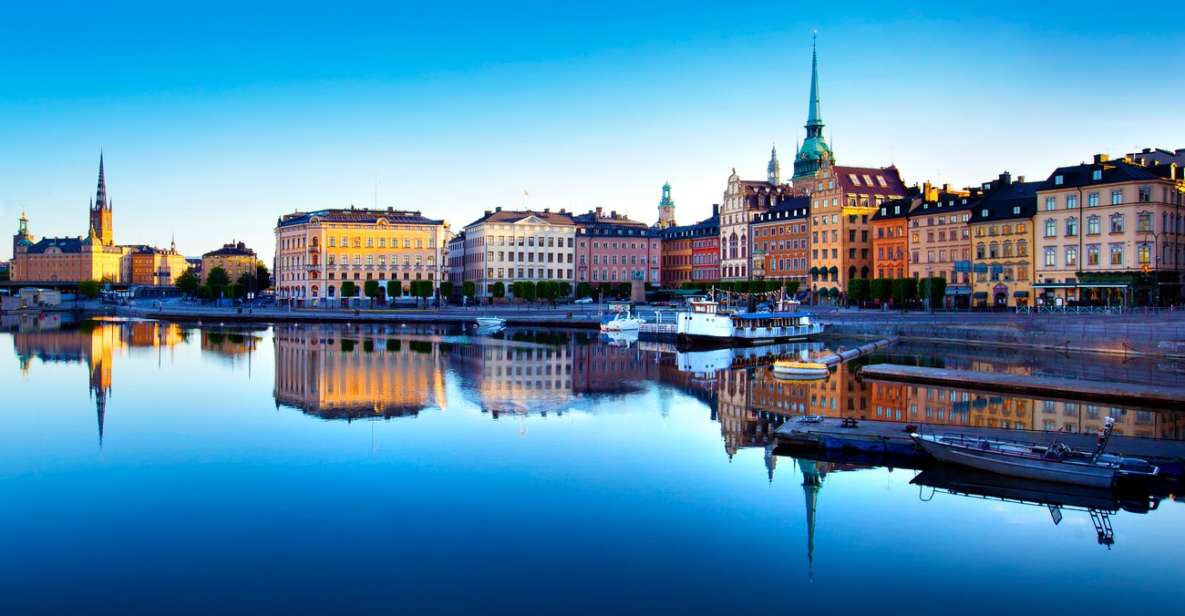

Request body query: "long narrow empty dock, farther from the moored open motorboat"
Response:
[860, 364, 1185, 410]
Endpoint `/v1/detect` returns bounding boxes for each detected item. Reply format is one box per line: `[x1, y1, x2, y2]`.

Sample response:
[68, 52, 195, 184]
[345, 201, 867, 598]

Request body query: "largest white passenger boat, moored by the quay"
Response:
[675, 300, 822, 345]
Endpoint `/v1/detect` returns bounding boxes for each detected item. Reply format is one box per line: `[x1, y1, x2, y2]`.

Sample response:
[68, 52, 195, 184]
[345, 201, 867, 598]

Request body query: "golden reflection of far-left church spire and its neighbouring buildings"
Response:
[12, 320, 187, 445]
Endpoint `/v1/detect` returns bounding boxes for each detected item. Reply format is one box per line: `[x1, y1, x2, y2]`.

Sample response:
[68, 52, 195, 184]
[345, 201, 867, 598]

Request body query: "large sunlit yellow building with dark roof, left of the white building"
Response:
[273, 207, 448, 306]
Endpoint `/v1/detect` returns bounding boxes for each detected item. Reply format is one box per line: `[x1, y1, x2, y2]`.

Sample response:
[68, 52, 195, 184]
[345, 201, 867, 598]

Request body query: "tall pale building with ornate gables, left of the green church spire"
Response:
[719, 155, 794, 281]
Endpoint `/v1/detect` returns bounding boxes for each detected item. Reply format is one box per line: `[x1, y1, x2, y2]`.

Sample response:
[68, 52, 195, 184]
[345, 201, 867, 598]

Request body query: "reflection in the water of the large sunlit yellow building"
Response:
[274, 323, 448, 421]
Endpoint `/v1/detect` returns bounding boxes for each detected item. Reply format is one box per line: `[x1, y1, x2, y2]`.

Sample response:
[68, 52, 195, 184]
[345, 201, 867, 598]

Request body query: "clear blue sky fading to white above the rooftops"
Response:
[0, 1, 1185, 259]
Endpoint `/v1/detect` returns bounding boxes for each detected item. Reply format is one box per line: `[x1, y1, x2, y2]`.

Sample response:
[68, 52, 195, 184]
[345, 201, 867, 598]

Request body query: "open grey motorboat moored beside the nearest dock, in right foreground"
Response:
[910, 417, 1160, 488]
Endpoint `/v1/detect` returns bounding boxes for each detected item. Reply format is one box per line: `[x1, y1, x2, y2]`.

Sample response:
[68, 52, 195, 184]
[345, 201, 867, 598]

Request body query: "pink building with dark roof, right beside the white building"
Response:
[571, 207, 662, 285]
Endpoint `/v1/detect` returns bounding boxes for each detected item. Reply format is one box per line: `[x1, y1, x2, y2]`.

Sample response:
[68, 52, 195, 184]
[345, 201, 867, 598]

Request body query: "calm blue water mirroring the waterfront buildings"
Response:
[0, 321, 1185, 614]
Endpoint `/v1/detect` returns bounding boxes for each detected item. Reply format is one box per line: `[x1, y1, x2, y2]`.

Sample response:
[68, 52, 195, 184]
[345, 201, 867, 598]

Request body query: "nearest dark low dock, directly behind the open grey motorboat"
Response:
[774, 417, 1185, 476]
